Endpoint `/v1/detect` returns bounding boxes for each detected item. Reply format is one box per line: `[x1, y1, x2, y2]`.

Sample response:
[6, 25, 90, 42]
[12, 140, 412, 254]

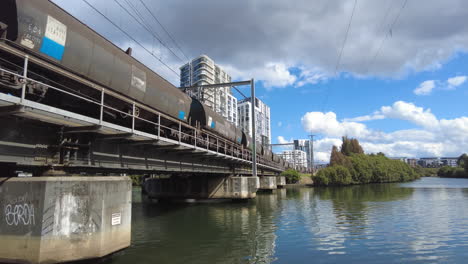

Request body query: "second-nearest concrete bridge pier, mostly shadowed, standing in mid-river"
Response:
[142, 175, 257, 199]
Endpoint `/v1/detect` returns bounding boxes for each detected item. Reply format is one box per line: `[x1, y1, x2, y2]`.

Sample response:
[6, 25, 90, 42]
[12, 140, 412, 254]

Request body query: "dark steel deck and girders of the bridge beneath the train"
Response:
[0, 64, 283, 174]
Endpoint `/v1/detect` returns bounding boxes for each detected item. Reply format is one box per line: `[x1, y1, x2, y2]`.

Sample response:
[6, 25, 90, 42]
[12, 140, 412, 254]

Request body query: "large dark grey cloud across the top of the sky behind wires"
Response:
[53, 0, 468, 87]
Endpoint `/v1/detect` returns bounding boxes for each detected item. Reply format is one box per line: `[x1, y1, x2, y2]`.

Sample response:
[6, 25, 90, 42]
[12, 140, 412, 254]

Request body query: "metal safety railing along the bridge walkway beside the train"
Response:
[0, 52, 279, 170]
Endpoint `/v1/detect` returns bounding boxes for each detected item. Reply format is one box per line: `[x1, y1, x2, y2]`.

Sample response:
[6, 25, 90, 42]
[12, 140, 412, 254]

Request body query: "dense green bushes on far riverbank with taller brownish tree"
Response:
[313, 137, 422, 186]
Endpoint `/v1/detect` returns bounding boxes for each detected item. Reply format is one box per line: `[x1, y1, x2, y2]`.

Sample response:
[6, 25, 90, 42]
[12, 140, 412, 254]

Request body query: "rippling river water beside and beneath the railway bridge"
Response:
[98, 178, 468, 264]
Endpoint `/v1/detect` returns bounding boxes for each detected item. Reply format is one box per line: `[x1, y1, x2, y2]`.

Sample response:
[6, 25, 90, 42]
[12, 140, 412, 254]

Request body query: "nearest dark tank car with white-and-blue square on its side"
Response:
[0, 0, 191, 122]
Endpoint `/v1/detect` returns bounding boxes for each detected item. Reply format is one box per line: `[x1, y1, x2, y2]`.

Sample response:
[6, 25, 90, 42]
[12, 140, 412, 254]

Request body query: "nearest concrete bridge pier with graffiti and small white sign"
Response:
[0, 177, 132, 263]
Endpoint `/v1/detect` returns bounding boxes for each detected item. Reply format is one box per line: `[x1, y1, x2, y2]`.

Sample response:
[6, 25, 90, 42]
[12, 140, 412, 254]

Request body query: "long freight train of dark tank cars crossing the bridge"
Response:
[0, 0, 290, 168]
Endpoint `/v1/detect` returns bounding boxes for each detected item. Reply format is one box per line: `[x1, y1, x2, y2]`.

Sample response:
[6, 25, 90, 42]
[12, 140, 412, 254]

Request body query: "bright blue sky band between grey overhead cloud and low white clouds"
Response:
[264, 54, 468, 139]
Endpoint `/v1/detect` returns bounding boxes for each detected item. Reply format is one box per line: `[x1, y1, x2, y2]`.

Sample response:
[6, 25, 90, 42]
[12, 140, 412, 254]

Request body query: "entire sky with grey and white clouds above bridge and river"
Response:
[53, 0, 468, 162]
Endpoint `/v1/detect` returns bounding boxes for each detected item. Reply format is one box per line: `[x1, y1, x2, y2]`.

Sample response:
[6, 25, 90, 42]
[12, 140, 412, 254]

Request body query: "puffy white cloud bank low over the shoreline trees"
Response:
[301, 101, 468, 158]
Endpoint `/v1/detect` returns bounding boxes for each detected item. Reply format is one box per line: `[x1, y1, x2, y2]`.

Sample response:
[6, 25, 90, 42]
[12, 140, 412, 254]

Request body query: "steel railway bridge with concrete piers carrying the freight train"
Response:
[0, 50, 285, 263]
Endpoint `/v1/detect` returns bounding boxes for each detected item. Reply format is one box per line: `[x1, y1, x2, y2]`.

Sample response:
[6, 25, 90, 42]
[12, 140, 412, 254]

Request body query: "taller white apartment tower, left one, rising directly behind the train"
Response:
[180, 55, 237, 125]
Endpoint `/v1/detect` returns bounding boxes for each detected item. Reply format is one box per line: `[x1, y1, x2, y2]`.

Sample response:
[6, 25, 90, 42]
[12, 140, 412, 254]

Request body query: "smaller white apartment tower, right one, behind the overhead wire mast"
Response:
[237, 98, 271, 145]
